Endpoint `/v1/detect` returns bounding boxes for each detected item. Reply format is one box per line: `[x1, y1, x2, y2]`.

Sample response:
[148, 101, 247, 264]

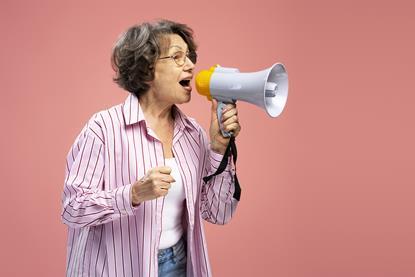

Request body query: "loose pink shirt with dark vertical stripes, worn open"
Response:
[62, 94, 238, 277]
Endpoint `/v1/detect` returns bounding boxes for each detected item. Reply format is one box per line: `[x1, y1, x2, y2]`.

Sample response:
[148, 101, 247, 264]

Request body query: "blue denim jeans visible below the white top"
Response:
[158, 237, 187, 277]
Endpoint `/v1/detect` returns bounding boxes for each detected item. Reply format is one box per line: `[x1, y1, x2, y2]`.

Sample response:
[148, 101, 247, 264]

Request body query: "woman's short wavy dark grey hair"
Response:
[111, 19, 197, 98]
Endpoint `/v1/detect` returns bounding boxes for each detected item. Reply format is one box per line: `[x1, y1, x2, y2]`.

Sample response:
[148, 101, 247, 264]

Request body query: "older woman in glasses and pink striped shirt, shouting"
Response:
[62, 20, 240, 276]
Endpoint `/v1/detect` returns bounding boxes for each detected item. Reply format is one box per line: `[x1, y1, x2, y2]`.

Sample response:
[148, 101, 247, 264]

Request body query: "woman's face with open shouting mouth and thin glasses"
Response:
[149, 34, 195, 104]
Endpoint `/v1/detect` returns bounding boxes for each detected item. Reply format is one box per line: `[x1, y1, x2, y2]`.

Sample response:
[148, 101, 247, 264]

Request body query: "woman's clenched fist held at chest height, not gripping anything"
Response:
[131, 166, 175, 206]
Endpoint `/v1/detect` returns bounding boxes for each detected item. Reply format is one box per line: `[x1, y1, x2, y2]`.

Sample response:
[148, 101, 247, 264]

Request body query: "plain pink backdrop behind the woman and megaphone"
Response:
[0, 0, 415, 277]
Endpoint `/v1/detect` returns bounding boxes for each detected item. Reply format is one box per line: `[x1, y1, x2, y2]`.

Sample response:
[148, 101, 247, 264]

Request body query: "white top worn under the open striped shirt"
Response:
[159, 158, 186, 249]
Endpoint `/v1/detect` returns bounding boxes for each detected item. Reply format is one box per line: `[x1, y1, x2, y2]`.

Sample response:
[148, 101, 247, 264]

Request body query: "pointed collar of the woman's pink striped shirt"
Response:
[123, 93, 198, 130]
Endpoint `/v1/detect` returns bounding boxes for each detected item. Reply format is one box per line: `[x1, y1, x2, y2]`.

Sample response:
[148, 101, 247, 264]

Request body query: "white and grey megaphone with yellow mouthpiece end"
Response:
[196, 63, 288, 137]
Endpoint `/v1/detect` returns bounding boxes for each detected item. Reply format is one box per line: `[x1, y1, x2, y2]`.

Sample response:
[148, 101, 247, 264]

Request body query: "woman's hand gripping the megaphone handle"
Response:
[209, 99, 241, 155]
